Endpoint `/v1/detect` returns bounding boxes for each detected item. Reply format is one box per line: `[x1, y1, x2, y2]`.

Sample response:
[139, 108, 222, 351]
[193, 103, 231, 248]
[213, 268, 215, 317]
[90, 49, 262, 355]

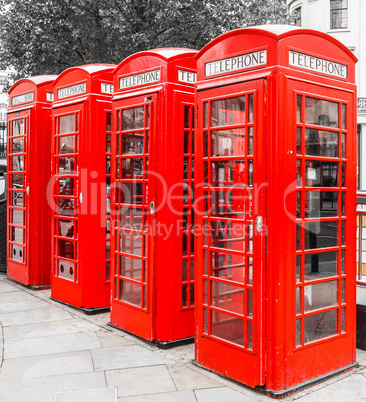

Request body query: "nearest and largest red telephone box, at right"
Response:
[195, 26, 356, 396]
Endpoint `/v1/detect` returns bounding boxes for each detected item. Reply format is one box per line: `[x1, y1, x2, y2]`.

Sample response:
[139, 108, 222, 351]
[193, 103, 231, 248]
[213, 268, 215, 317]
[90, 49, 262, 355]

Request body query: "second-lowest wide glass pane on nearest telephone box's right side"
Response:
[304, 281, 338, 312]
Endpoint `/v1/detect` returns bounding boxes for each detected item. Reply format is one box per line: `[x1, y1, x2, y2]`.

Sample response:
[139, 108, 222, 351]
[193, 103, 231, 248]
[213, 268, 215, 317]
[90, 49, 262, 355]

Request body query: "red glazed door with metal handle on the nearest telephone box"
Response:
[195, 80, 266, 386]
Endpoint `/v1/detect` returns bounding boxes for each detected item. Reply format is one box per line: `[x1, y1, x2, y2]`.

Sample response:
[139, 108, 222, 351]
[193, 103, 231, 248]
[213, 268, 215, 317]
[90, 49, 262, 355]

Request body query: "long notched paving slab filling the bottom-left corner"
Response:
[0, 373, 105, 402]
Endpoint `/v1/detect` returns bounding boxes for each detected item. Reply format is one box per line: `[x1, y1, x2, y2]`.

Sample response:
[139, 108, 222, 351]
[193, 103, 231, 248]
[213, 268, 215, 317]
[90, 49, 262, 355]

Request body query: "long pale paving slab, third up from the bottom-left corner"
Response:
[4, 332, 101, 359]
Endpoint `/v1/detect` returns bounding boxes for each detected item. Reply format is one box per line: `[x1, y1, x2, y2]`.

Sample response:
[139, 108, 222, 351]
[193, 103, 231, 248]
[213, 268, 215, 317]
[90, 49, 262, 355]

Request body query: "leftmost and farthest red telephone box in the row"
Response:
[7, 75, 57, 288]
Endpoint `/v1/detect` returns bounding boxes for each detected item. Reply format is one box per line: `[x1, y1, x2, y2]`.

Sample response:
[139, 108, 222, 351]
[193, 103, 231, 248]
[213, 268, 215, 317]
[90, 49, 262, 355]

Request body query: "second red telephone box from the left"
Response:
[51, 64, 115, 312]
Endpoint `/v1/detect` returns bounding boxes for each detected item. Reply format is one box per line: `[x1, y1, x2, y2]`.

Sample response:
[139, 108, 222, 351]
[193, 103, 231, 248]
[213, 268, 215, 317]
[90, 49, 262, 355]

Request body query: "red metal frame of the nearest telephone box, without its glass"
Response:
[195, 26, 356, 396]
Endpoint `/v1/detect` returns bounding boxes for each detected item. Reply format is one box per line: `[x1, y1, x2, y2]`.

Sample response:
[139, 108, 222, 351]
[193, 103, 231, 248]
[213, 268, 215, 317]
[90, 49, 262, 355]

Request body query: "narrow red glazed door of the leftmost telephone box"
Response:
[8, 110, 29, 270]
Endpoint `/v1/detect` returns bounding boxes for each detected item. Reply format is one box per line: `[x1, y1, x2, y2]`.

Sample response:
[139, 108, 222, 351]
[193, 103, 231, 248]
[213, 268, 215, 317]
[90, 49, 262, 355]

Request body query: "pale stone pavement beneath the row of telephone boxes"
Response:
[0, 274, 366, 402]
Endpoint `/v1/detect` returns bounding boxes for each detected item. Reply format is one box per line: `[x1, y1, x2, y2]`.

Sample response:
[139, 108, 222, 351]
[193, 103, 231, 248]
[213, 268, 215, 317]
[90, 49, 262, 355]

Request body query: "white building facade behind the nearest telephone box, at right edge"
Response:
[286, 0, 366, 305]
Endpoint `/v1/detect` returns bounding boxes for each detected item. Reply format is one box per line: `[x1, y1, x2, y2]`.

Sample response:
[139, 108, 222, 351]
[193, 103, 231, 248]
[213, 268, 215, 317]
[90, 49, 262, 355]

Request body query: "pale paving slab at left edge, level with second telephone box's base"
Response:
[0, 290, 48, 315]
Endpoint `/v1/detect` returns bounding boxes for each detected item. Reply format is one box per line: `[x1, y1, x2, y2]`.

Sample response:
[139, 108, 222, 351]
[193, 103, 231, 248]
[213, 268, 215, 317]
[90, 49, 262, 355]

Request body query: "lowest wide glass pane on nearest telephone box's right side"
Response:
[304, 310, 337, 343]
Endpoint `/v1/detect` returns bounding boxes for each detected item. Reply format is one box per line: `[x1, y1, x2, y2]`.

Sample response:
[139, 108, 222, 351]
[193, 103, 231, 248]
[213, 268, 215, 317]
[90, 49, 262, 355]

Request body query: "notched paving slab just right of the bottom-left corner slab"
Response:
[106, 365, 177, 397]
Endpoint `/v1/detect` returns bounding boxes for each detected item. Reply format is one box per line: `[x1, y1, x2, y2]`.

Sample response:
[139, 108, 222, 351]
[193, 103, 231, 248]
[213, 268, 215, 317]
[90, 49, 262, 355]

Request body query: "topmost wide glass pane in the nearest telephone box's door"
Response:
[211, 96, 245, 127]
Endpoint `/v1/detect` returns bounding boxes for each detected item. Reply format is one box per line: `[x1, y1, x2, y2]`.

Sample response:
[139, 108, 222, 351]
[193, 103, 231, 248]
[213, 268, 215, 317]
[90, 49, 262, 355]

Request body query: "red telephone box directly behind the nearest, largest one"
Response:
[111, 48, 197, 347]
